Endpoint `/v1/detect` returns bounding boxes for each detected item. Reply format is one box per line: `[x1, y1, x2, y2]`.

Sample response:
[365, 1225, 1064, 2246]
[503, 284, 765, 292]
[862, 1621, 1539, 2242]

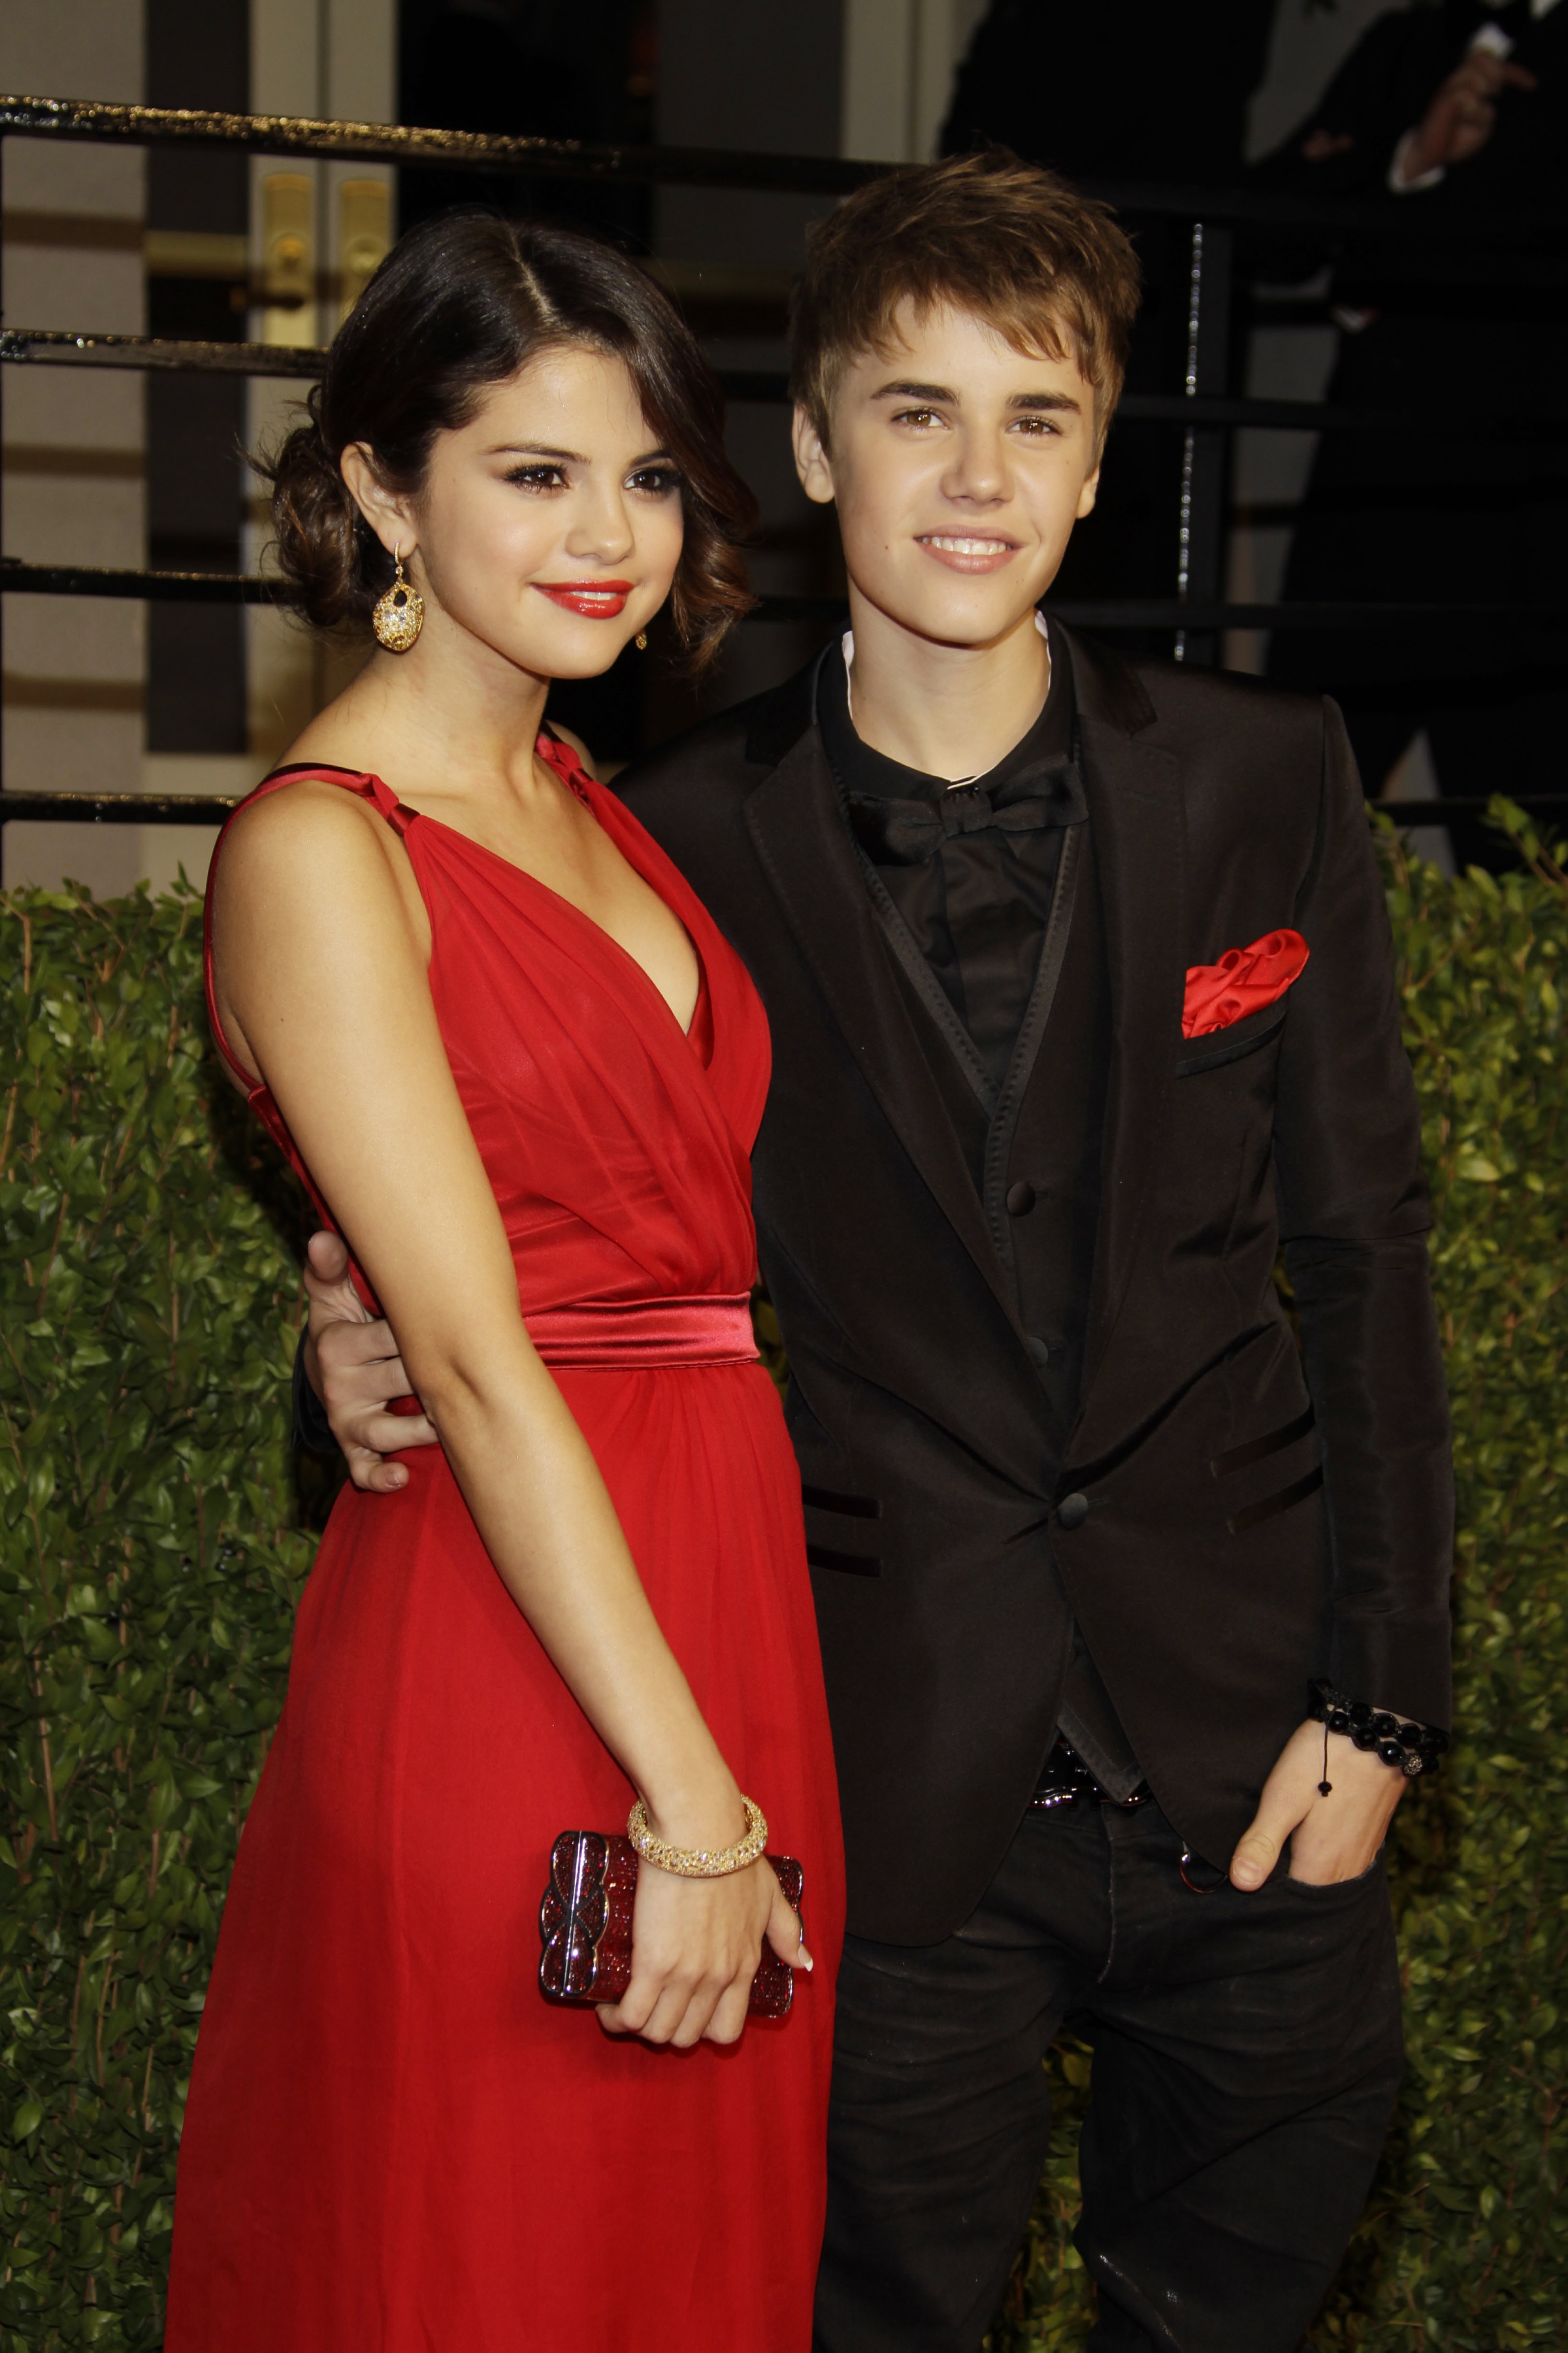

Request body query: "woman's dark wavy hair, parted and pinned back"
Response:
[254, 212, 756, 670]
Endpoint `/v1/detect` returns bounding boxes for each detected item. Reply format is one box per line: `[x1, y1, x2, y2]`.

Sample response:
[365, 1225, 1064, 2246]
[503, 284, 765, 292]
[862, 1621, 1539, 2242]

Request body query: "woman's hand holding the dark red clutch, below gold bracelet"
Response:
[598, 1856, 812, 2049]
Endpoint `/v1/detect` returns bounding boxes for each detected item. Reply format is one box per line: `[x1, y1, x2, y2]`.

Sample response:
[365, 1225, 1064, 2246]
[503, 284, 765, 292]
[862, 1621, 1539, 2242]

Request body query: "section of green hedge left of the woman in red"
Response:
[0, 892, 325, 2353]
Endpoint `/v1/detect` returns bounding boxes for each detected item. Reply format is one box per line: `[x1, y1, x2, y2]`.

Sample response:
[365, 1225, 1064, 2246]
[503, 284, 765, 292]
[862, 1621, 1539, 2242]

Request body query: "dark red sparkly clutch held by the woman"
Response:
[539, 1831, 805, 2019]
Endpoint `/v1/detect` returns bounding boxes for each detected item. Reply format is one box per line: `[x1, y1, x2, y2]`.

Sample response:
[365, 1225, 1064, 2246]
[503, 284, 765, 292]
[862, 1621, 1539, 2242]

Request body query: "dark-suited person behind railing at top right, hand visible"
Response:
[1255, 0, 1568, 814]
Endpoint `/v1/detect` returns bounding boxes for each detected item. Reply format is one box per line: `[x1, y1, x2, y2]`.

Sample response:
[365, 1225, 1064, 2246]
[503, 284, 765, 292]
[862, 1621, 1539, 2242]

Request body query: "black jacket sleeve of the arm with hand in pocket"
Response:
[1274, 704, 1452, 1727]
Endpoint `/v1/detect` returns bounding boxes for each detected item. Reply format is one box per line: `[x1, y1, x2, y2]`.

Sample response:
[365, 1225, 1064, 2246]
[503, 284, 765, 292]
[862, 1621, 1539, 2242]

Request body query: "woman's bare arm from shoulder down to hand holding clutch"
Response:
[214, 782, 800, 2043]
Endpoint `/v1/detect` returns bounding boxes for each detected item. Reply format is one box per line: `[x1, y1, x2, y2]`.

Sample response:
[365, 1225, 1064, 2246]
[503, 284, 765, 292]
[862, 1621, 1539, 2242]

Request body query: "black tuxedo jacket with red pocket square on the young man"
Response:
[621, 628, 1452, 1943]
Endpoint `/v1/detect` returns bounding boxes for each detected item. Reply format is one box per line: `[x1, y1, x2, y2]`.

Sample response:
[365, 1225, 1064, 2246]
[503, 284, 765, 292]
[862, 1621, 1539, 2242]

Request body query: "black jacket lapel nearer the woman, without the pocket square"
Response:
[744, 725, 1022, 1341]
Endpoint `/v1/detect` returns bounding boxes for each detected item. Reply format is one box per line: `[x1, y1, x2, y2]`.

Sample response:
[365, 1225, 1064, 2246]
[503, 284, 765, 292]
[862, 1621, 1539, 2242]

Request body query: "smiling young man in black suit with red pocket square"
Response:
[299, 156, 1450, 2353]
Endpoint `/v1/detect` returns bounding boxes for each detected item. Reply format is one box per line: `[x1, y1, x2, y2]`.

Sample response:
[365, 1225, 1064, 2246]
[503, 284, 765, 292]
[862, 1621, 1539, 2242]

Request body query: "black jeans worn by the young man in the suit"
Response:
[815, 1802, 1401, 2353]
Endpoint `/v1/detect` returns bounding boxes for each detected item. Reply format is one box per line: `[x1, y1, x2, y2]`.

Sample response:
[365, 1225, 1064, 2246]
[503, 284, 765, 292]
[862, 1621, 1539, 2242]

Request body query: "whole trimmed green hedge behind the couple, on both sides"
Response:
[0, 800, 1568, 2353]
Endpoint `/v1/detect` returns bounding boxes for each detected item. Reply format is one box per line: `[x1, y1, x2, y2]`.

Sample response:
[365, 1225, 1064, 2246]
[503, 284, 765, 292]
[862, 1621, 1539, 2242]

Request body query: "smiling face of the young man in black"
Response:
[796, 304, 1100, 647]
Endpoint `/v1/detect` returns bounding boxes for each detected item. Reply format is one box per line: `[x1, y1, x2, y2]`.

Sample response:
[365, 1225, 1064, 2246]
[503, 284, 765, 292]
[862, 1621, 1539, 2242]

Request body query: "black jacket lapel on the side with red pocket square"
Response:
[1069, 640, 1186, 1411]
